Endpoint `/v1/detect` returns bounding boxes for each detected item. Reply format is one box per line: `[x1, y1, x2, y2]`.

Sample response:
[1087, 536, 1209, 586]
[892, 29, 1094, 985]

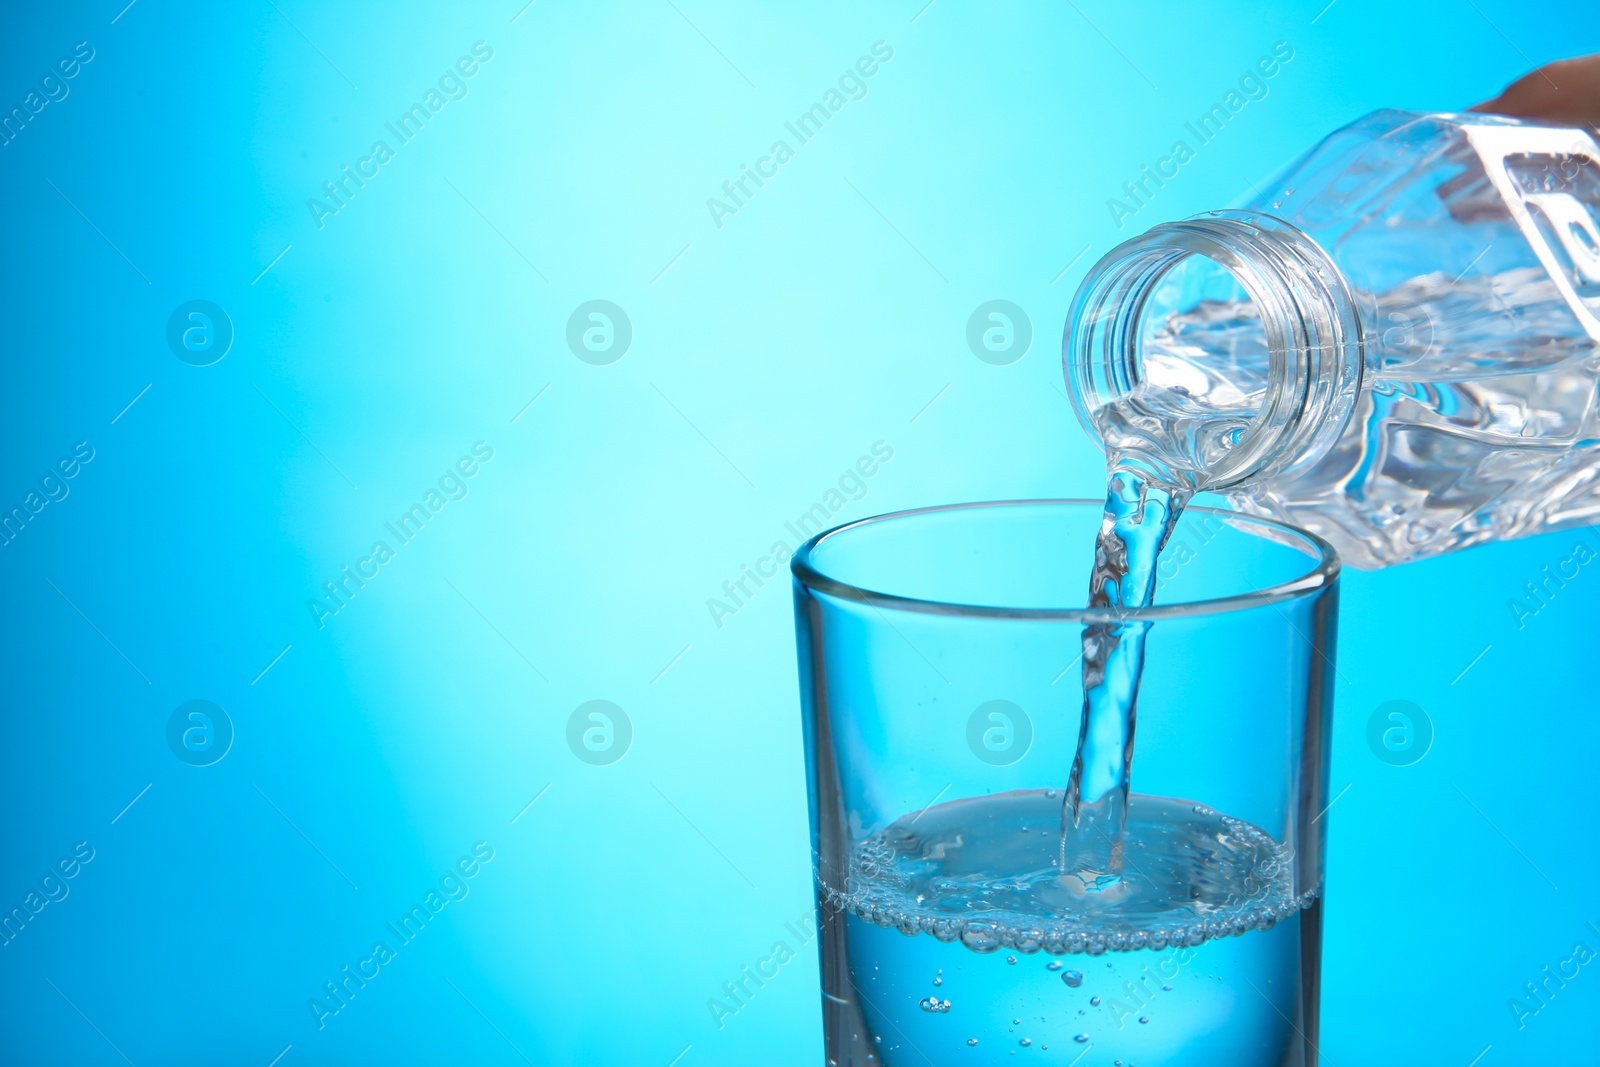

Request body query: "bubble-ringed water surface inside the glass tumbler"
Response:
[821, 790, 1320, 959]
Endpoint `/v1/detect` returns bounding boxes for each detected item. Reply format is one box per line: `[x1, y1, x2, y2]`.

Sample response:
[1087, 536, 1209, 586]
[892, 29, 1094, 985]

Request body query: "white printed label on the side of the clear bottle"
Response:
[1461, 125, 1600, 341]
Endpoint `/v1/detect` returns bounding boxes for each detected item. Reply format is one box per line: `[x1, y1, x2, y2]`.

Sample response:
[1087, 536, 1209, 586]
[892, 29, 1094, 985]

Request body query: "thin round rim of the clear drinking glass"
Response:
[789, 498, 1342, 624]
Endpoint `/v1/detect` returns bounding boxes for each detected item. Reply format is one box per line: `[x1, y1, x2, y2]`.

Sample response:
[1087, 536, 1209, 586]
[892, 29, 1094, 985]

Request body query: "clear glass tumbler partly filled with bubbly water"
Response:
[792, 501, 1339, 1067]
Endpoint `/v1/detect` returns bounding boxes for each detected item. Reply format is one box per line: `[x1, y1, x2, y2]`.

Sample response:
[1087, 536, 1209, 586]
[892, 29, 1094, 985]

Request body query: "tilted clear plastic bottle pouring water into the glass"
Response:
[1062, 110, 1600, 568]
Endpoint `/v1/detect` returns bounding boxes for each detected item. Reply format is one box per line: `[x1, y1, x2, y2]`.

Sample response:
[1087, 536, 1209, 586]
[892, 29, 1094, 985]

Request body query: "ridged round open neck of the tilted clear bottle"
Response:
[1062, 211, 1363, 491]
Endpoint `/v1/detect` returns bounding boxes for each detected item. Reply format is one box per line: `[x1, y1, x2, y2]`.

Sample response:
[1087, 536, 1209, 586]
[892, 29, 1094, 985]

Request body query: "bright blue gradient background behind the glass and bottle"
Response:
[0, 0, 1600, 1067]
